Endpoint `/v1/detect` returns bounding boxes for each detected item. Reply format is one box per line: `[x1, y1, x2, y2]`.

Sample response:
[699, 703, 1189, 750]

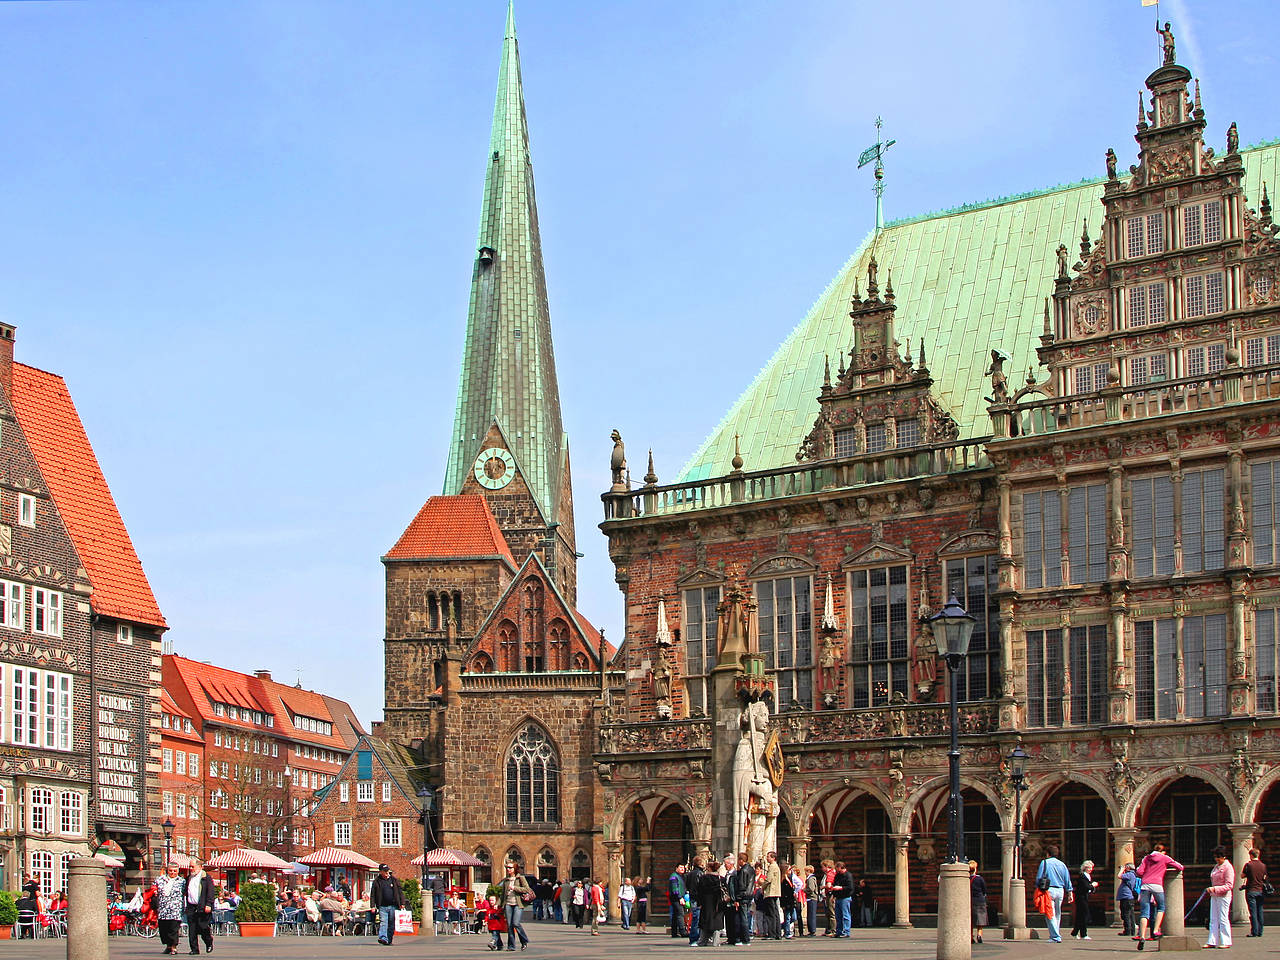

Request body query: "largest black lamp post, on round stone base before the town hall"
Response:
[929, 595, 974, 960]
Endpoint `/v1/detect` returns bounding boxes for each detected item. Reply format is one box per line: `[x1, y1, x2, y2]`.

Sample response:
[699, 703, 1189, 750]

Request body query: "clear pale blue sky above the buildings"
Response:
[0, 0, 1280, 722]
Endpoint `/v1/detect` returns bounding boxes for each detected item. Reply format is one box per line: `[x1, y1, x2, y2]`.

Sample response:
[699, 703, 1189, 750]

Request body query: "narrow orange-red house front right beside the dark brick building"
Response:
[155, 691, 205, 858]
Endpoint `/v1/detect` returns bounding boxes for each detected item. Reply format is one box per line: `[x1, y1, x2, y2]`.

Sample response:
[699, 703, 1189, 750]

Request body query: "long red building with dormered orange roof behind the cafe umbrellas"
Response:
[164, 654, 365, 860]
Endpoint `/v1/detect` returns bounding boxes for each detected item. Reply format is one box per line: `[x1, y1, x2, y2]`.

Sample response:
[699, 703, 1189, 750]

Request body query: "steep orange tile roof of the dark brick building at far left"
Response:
[10, 364, 166, 628]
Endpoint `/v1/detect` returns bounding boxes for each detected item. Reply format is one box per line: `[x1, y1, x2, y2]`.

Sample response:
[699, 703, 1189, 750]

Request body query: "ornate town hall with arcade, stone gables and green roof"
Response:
[594, 36, 1280, 923]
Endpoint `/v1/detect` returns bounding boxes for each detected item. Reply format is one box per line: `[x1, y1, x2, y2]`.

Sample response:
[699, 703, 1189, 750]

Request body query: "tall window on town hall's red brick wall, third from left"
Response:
[849, 566, 910, 708]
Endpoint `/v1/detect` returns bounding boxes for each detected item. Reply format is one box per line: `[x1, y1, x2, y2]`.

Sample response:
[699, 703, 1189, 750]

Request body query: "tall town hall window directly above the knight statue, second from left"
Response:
[755, 576, 813, 709]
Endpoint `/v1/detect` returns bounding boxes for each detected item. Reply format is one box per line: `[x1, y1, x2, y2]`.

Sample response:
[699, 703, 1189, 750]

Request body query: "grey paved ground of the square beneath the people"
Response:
[0, 923, 1280, 960]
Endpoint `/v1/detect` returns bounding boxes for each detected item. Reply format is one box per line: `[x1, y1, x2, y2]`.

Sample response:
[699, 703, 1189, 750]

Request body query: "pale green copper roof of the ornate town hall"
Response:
[678, 141, 1280, 481]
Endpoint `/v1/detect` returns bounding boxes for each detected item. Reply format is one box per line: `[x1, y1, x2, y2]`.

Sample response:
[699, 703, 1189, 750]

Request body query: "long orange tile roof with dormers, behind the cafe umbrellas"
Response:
[164, 654, 365, 753]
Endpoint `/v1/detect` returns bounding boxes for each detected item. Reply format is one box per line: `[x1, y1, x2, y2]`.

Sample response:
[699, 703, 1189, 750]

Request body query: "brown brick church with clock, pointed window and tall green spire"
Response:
[375, 6, 612, 876]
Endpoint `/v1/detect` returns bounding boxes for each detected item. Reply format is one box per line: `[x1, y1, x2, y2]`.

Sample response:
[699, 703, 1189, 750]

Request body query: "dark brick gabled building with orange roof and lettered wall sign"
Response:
[0, 324, 166, 891]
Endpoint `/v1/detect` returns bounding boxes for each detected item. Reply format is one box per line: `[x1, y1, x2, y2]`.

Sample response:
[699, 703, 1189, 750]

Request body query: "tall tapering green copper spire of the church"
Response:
[444, 4, 566, 522]
